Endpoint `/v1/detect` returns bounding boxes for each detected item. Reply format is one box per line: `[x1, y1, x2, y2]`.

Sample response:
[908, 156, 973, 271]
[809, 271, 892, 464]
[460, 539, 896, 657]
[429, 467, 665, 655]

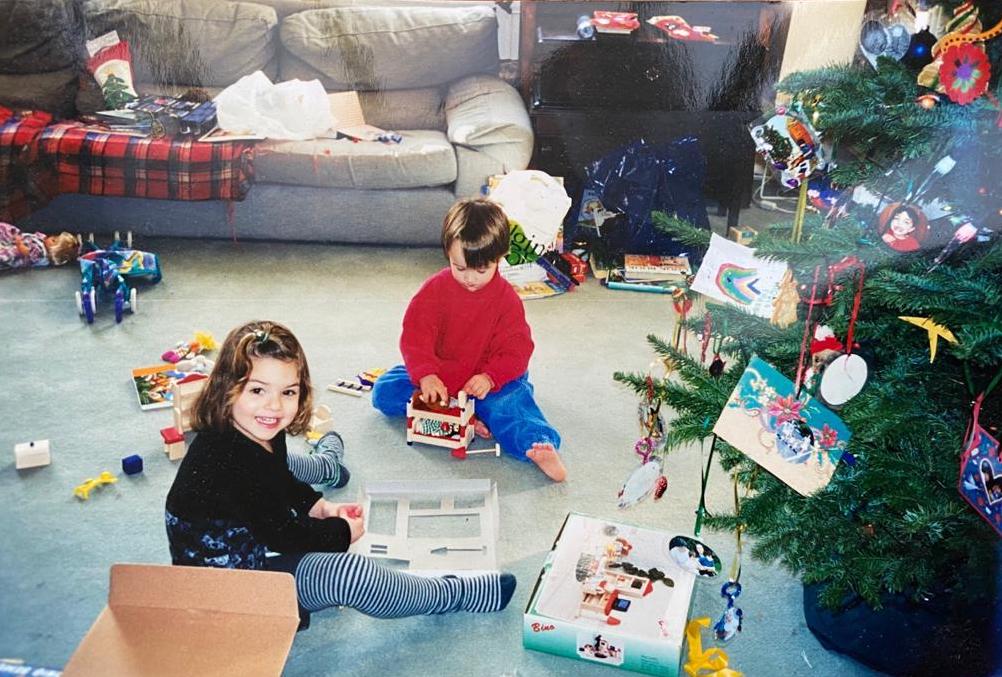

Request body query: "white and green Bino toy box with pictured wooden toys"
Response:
[522, 513, 694, 677]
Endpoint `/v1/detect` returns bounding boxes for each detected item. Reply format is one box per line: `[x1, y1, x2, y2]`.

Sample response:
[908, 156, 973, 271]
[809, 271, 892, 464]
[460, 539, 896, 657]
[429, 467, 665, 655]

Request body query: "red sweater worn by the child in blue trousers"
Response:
[400, 268, 533, 395]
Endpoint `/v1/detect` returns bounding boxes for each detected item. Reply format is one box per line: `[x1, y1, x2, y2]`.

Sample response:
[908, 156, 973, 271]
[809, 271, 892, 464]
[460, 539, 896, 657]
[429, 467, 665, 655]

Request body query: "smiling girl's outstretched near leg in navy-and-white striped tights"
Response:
[296, 553, 511, 618]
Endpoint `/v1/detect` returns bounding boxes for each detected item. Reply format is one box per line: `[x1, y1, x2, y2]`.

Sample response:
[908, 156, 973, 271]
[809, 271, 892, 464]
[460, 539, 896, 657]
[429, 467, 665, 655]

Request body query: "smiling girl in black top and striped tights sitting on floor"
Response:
[165, 321, 515, 627]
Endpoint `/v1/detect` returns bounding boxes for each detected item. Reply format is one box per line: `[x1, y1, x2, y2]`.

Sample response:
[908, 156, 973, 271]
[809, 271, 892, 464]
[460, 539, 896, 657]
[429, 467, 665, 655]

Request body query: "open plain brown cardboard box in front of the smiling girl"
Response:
[63, 564, 299, 677]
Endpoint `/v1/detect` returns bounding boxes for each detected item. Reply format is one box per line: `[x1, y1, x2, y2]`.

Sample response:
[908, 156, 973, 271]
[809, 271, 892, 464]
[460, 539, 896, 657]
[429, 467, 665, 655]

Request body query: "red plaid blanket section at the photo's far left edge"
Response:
[0, 106, 55, 221]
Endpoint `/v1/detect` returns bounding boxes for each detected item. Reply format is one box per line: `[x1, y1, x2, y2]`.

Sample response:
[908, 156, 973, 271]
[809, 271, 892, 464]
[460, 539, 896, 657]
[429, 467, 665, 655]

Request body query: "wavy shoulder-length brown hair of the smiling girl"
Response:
[191, 320, 313, 435]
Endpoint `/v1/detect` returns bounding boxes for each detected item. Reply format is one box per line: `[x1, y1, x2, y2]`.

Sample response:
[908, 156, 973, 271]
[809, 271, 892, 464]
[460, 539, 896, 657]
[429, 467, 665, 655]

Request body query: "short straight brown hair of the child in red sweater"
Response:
[442, 197, 510, 268]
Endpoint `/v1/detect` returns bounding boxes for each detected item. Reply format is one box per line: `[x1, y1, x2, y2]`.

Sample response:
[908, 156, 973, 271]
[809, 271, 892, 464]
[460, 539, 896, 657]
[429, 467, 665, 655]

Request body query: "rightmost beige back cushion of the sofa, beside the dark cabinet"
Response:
[280, 5, 498, 90]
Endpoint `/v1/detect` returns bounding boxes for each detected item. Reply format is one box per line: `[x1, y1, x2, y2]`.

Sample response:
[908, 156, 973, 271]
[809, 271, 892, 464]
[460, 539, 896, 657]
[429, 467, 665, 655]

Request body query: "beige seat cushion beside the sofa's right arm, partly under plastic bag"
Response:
[255, 130, 456, 188]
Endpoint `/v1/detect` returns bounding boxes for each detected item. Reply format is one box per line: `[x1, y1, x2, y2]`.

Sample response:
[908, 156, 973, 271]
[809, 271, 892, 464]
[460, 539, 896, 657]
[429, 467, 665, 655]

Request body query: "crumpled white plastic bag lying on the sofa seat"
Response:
[215, 70, 334, 140]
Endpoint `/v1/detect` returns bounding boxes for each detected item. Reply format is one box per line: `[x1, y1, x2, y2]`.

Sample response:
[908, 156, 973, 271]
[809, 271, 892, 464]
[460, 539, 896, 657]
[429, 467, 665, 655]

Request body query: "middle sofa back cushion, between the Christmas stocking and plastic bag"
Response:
[84, 0, 279, 87]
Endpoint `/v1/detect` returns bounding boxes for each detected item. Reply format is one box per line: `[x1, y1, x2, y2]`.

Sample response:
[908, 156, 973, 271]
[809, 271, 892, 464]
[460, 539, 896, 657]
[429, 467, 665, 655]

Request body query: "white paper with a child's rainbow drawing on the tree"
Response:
[692, 232, 787, 319]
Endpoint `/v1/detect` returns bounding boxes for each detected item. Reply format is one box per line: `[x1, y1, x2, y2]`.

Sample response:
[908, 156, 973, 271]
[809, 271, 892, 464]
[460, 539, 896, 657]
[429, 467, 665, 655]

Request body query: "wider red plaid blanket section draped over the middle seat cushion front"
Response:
[38, 122, 254, 200]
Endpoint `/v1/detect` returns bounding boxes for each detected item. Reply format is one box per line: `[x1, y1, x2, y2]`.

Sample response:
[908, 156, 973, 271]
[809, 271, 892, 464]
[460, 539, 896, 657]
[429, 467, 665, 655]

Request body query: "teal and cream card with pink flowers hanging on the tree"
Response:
[713, 357, 852, 496]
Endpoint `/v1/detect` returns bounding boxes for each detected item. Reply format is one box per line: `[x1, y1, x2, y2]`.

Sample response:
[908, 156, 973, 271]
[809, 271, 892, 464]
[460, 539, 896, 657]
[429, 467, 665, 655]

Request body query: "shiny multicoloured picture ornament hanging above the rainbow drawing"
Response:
[750, 106, 825, 188]
